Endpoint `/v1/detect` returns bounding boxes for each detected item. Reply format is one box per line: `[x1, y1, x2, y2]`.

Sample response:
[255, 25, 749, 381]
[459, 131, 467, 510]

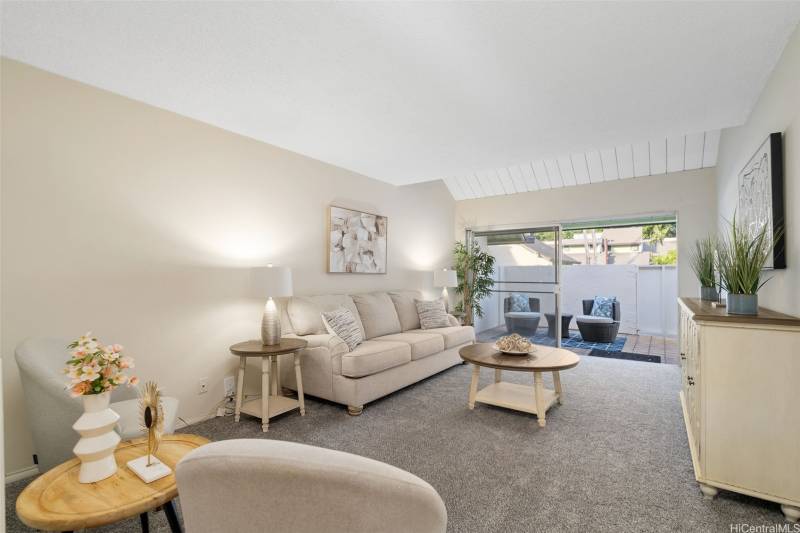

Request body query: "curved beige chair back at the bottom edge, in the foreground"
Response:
[175, 439, 447, 533]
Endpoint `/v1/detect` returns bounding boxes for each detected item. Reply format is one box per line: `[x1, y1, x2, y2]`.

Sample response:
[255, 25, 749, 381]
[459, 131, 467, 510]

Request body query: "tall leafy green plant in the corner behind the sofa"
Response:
[453, 242, 494, 326]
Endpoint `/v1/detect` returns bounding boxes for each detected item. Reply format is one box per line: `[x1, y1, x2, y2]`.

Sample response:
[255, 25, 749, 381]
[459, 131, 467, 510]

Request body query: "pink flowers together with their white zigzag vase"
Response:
[64, 333, 138, 483]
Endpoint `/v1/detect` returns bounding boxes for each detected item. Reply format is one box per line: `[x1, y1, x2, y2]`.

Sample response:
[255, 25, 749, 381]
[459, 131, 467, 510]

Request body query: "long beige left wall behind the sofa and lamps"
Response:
[2, 59, 454, 472]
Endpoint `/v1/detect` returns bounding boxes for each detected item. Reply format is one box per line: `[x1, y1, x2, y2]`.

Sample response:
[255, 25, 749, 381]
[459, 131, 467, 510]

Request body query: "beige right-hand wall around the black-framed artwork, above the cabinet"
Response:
[717, 23, 800, 315]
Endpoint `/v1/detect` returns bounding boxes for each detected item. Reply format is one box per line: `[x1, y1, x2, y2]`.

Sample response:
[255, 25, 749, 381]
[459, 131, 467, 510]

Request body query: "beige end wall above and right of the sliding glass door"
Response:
[455, 168, 716, 302]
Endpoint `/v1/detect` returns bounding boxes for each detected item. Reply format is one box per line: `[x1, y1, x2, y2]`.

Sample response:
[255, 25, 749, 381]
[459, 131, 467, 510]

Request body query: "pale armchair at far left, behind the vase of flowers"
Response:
[14, 338, 178, 472]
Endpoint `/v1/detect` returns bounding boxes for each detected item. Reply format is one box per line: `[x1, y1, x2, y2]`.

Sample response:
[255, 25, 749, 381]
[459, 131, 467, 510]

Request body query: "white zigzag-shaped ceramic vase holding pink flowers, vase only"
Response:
[72, 392, 121, 483]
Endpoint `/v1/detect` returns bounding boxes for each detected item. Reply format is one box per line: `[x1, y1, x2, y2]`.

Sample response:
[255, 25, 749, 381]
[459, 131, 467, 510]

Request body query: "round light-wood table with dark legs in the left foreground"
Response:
[17, 435, 210, 533]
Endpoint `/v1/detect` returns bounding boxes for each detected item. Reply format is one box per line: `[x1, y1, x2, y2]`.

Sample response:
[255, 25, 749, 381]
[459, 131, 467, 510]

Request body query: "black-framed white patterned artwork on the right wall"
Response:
[736, 133, 786, 269]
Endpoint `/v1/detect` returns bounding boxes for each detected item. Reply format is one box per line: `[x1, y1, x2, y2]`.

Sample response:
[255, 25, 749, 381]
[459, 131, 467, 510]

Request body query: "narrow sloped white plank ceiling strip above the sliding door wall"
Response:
[444, 130, 719, 200]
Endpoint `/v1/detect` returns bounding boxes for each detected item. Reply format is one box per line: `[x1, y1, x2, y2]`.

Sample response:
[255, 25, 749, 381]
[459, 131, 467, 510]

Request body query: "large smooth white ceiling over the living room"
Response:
[2, 2, 800, 186]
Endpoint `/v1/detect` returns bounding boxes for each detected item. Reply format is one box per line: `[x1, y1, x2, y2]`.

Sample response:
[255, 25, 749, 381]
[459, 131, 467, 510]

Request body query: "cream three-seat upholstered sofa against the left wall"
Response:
[280, 291, 475, 415]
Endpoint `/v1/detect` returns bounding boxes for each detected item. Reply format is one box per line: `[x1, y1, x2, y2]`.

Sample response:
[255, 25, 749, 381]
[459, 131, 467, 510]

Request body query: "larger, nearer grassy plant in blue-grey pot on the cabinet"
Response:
[717, 215, 773, 315]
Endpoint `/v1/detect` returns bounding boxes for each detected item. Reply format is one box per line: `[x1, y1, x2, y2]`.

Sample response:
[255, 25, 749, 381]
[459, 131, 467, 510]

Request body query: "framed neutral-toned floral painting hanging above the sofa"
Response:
[328, 206, 388, 274]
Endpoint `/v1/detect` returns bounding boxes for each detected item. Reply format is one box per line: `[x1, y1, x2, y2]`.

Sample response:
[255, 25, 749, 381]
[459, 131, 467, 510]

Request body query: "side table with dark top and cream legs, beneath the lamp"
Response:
[230, 337, 308, 433]
